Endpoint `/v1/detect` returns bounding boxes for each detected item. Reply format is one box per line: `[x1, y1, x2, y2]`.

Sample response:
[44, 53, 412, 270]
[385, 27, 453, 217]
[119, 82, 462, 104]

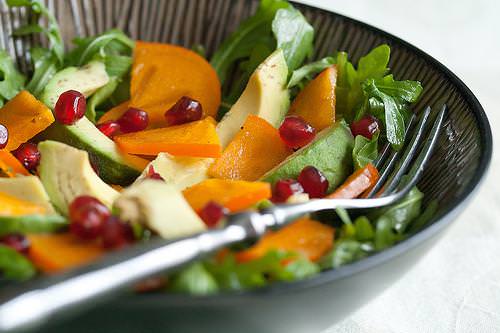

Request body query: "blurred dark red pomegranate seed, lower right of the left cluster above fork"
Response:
[101, 216, 134, 249]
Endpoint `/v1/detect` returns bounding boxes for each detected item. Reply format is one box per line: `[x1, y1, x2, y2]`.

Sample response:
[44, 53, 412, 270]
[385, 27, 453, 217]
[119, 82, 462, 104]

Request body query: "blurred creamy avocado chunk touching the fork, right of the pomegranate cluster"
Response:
[114, 179, 206, 239]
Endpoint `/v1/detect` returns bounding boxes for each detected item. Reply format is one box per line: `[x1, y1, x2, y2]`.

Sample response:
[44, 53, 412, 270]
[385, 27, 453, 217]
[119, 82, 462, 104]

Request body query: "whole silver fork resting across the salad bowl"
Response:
[0, 105, 446, 332]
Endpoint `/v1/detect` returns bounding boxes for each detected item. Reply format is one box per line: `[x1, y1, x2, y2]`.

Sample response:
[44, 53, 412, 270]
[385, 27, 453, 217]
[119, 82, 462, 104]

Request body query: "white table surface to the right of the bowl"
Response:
[296, 0, 500, 333]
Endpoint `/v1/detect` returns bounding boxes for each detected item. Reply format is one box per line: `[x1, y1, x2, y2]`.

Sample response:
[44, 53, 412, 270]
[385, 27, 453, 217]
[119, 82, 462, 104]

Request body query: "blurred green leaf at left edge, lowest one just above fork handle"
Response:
[0, 245, 36, 281]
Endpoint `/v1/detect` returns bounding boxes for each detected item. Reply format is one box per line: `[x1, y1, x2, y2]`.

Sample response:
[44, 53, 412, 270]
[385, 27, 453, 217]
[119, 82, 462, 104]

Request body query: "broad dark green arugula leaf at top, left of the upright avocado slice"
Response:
[210, 0, 290, 84]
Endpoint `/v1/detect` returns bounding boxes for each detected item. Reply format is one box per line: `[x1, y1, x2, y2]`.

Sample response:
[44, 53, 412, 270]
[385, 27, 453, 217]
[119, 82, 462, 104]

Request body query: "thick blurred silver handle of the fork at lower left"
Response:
[0, 222, 252, 332]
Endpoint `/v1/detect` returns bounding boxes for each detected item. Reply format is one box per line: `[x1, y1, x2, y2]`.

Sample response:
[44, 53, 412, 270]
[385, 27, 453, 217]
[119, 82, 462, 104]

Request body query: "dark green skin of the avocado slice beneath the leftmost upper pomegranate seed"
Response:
[35, 121, 141, 186]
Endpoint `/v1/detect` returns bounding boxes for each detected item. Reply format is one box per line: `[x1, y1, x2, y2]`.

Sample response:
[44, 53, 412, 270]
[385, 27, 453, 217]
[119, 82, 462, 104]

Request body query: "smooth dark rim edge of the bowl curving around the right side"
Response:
[127, 1, 493, 304]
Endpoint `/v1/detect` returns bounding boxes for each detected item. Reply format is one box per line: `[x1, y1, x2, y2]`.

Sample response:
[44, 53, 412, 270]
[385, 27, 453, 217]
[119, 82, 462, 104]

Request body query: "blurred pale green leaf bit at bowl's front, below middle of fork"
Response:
[170, 262, 219, 295]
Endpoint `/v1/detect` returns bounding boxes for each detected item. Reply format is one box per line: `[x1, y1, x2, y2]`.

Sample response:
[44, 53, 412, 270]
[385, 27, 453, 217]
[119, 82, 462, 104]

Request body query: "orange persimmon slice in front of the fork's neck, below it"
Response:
[236, 218, 334, 262]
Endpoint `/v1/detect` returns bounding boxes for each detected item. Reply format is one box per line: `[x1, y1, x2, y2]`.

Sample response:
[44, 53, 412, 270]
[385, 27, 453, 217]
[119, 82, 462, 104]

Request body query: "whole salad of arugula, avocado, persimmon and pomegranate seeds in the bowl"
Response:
[0, 0, 437, 295]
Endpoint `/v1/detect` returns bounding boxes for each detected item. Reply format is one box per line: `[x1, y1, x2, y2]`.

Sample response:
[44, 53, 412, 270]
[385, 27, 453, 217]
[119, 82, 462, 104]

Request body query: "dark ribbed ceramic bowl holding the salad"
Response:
[0, 0, 492, 333]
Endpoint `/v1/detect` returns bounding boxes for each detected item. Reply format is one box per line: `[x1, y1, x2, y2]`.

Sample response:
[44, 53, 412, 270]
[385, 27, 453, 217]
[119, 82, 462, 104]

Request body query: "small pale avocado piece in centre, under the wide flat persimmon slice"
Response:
[135, 153, 214, 191]
